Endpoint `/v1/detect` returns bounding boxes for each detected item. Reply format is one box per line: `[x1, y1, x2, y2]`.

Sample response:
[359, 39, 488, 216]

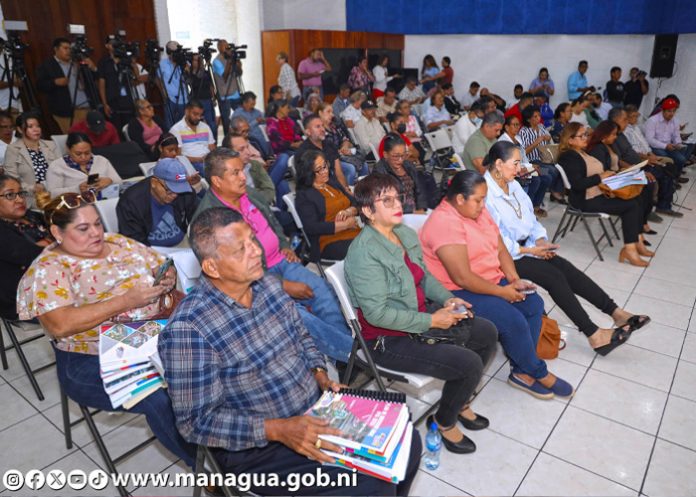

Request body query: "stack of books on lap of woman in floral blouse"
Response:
[99, 319, 167, 409]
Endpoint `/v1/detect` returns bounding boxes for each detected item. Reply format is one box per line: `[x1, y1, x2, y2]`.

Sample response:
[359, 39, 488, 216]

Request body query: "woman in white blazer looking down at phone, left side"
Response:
[46, 133, 121, 197]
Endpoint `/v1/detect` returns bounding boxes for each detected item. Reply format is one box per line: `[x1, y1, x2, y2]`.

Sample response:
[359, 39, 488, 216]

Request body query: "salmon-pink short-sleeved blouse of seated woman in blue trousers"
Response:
[419, 200, 505, 290]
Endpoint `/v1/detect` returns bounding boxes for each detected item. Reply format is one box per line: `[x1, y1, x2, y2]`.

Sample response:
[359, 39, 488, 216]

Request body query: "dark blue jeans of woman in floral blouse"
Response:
[55, 349, 196, 468]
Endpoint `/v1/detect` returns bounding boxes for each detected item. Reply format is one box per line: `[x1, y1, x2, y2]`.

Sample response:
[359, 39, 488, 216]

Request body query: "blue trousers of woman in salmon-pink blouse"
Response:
[452, 278, 548, 379]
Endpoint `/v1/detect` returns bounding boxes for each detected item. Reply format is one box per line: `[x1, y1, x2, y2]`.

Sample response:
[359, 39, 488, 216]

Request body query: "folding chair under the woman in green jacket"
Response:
[326, 261, 439, 425]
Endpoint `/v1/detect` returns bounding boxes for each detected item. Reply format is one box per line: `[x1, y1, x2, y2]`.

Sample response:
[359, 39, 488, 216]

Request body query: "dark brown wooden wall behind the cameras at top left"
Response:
[0, 0, 157, 134]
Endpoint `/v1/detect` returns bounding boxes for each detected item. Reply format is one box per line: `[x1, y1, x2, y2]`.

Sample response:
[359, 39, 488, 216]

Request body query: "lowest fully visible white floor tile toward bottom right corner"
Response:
[544, 406, 654, 490]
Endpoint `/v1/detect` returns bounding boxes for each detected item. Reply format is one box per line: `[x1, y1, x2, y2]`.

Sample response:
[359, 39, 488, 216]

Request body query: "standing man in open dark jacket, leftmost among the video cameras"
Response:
[36, 38, 97, 134]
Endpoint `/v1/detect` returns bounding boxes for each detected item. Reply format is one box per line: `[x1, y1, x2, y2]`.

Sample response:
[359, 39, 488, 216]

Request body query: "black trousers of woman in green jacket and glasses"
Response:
[367, 317, 498, 427]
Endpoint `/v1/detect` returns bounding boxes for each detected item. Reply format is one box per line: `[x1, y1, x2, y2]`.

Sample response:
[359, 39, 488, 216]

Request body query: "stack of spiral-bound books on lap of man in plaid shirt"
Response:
[307, 390, 413, 483]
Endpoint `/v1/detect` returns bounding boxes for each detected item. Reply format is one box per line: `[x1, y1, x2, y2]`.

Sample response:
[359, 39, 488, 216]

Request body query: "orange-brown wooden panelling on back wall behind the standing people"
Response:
[261, 29, 404, 100]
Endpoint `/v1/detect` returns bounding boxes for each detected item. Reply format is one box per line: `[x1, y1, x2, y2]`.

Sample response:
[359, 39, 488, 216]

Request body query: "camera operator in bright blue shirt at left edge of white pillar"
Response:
[160, 40, 190, 129]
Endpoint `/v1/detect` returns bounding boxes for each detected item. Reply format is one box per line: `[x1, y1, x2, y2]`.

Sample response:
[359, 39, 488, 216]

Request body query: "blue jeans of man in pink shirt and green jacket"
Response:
[268, 259, 353, 362]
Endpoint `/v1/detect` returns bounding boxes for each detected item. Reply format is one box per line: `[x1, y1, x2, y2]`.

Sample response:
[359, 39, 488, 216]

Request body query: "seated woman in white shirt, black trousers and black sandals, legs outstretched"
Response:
[484, 142, 650, 355]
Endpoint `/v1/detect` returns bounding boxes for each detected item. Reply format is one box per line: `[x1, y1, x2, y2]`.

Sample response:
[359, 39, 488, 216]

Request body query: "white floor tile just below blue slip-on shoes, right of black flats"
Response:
[466, 378, 563, 449]
